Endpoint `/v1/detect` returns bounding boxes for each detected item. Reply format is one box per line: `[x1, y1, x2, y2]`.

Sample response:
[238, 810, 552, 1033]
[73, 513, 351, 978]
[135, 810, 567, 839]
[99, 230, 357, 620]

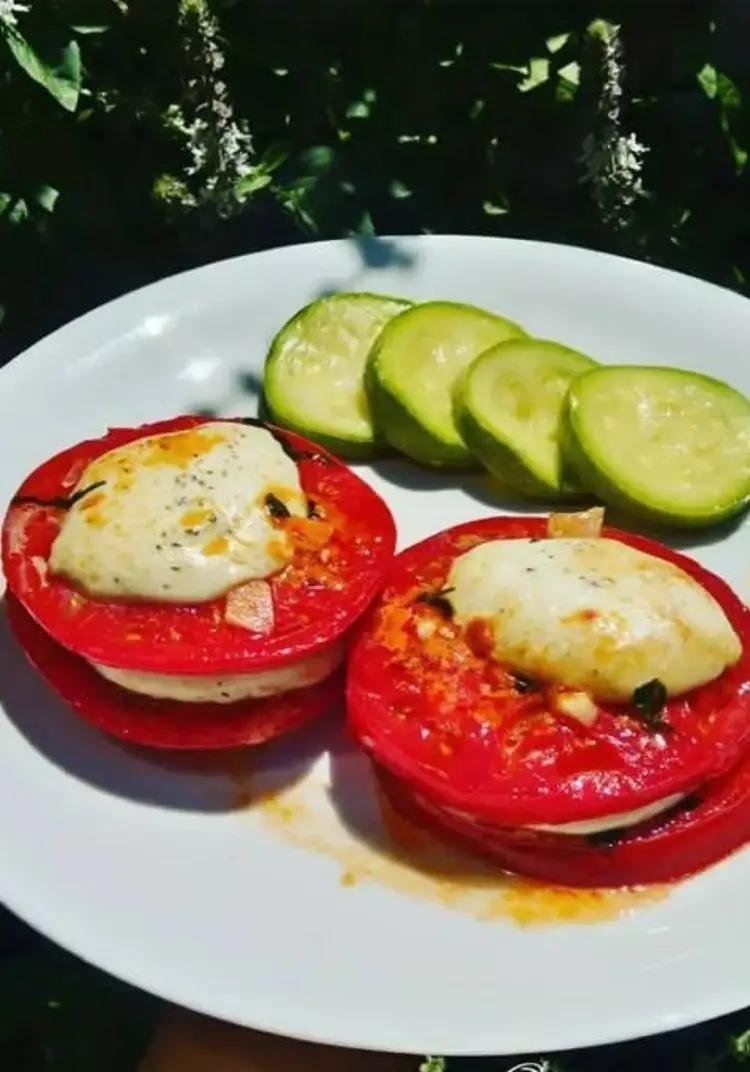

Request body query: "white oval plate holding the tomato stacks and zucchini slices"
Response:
[0, 237, 750, 1054]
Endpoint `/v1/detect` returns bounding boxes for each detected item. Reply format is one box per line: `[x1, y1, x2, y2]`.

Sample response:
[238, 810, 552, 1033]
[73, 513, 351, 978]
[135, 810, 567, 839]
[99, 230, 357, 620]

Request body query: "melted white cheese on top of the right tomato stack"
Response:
[447, 539, 741, 702]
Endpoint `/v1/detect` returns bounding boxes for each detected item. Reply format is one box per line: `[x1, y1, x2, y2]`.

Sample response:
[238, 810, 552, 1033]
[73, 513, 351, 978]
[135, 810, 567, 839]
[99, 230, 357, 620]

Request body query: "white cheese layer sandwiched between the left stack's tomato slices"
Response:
[91, 641, 344, 703]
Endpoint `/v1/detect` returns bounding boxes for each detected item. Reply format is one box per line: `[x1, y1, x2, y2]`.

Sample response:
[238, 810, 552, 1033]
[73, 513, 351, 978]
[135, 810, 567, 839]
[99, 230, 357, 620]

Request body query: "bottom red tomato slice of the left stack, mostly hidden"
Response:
[5, 595, 343, 749]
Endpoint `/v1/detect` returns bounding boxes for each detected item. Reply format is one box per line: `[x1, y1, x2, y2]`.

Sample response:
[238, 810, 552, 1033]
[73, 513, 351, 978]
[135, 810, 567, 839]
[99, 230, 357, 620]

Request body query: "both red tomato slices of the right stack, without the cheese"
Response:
[348, 518, 750, 887]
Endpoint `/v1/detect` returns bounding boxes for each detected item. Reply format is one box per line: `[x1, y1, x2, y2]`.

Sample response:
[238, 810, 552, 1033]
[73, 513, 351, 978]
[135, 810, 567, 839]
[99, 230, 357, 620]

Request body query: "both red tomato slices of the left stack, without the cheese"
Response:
[2, 417, 395, 748]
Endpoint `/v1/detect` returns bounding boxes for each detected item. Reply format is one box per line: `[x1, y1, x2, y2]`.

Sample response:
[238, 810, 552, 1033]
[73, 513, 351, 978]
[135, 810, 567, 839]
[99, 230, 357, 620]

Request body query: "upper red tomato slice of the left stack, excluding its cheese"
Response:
[2, 417, 395, 674]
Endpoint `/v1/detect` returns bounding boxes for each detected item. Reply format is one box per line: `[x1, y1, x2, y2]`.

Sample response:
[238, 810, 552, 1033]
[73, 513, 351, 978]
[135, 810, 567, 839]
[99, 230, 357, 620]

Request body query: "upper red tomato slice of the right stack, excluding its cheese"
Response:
[347, 518, 750, 827]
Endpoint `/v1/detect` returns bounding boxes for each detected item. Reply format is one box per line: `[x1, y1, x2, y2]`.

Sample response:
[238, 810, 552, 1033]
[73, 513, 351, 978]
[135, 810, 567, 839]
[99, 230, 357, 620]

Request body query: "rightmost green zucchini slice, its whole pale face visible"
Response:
[564, 366, 750, 527]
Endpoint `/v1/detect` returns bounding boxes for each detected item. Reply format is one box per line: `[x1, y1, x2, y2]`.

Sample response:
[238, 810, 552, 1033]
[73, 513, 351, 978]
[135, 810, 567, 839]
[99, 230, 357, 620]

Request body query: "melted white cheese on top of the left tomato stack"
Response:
[49, 422, 305, 602]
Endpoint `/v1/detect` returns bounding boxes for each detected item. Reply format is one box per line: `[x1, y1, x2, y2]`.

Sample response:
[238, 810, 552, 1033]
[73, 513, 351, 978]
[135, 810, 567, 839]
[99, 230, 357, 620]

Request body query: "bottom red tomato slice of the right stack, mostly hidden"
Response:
[378, 751, 750, 888]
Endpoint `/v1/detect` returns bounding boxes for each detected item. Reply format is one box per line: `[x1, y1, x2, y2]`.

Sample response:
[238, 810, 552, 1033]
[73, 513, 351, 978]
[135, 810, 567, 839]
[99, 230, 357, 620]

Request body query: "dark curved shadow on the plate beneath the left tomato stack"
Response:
[0, 607, 325, 813]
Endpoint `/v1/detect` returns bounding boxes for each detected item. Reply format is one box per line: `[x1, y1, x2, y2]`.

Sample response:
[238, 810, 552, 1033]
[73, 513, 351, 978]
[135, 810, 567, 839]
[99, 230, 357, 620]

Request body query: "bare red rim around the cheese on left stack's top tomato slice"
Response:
[2, 417, 395, 674]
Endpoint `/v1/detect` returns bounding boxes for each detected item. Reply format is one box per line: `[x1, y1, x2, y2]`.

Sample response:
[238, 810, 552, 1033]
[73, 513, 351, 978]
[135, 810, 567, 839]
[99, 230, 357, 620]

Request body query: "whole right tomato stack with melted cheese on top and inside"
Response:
[347, 511, 750, 887]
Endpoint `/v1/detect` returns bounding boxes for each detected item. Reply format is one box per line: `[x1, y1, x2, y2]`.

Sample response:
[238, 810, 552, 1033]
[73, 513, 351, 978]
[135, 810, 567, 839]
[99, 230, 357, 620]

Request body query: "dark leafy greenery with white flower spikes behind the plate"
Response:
[0, 0, 750, 358]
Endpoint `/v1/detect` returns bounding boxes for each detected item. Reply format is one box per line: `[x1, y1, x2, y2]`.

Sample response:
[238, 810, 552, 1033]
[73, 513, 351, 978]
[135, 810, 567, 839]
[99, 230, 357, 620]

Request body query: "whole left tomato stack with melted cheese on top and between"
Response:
[2, 417, 395, 748]
